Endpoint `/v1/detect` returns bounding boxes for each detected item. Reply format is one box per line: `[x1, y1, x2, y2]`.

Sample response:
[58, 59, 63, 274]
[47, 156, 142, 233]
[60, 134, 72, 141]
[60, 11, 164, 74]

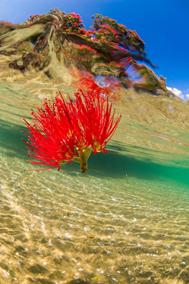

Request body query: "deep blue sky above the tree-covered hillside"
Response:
[0, 0, 189, 93]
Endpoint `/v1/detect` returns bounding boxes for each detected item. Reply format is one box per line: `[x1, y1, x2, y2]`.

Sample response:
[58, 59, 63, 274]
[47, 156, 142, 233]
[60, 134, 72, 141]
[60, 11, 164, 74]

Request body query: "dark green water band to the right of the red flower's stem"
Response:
[66, 150, 189, 186]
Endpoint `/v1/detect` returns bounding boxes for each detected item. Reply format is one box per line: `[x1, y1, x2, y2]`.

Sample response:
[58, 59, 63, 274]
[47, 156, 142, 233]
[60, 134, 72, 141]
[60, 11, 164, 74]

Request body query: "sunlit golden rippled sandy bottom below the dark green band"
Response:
[0, 162, 189, 283]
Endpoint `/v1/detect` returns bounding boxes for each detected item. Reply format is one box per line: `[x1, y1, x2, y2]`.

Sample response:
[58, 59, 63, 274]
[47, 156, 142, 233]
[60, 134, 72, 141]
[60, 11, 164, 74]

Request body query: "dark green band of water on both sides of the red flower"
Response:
[0, 119, 189, 186]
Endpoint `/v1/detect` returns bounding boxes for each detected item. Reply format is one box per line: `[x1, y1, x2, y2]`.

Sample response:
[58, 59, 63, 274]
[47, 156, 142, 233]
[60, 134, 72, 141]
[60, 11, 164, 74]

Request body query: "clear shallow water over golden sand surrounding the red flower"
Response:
[0, 85, 189, 284]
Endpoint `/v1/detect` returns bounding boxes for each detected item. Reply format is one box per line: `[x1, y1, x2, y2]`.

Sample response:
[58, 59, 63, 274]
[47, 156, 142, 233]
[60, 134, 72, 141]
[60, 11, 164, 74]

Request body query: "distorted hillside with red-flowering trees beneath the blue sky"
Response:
[0, 10, 173, 95]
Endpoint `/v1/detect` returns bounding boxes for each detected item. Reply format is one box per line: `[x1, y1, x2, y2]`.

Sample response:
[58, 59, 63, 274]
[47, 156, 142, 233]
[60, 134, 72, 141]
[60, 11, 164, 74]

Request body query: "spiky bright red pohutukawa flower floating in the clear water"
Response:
[25, 88, 121, 172]
